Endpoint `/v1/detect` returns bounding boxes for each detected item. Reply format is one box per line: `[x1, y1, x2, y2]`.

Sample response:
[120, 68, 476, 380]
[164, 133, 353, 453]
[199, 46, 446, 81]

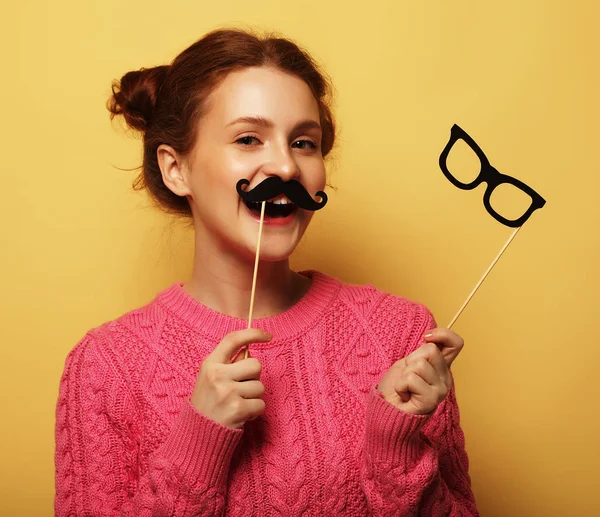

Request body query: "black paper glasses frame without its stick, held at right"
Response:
[440, 124, 546, 228]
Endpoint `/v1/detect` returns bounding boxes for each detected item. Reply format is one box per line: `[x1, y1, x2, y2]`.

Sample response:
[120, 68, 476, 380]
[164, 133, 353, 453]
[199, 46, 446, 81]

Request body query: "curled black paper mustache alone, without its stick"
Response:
[236, 176, 327, 211]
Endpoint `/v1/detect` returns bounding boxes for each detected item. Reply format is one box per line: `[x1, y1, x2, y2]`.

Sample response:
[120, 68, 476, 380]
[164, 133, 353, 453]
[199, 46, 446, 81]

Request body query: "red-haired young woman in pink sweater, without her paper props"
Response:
[55, 30, 477, 517]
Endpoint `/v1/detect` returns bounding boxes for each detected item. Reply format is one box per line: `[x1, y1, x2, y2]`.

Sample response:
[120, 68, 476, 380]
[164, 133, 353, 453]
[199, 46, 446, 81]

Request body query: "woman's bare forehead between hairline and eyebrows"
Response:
[206, 67, 319, 125]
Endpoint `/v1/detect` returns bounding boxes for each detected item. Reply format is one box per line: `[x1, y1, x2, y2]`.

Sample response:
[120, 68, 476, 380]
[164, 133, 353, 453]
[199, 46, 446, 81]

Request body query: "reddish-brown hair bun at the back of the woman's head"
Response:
[107, 65, 169, 132]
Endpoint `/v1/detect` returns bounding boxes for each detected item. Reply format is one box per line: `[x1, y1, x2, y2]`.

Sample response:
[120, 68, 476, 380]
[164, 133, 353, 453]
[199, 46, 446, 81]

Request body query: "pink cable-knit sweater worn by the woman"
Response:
[55, 271, 478, 517]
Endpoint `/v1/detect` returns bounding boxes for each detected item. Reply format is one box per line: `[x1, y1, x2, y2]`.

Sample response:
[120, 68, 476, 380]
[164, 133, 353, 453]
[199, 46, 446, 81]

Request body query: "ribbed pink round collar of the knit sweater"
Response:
[156, 270, 341, 340]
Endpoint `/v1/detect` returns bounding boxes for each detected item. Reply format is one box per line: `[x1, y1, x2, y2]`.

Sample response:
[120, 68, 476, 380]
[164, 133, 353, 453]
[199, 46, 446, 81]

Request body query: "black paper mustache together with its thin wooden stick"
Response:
[236, 176, 327, 359]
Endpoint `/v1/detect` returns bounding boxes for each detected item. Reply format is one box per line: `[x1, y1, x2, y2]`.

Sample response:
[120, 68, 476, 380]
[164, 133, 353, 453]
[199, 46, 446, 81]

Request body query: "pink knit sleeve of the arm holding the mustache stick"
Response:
[54, 334, 243, 517]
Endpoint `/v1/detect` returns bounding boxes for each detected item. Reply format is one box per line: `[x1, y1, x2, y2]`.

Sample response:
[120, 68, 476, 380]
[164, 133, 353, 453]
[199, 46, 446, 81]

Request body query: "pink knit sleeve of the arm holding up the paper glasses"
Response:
[361, 300, 479, 517]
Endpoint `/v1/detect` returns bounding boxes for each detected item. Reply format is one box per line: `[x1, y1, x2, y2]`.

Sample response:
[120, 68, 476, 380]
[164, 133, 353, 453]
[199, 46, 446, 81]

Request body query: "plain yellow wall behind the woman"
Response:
[0, 0, 600, 517]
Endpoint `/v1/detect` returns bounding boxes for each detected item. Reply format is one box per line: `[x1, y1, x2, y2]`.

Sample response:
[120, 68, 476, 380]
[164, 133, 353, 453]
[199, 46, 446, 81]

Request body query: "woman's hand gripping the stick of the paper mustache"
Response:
[191, 329, 273, 429]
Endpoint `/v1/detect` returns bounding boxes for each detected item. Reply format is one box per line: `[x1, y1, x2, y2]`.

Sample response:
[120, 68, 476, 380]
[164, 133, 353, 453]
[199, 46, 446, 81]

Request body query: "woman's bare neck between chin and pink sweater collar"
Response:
[184, 226, 311, 319]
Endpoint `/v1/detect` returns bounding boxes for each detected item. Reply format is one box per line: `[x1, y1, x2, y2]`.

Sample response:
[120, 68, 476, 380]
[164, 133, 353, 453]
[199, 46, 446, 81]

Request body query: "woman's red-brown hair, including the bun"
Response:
[107, 29, 335, 217]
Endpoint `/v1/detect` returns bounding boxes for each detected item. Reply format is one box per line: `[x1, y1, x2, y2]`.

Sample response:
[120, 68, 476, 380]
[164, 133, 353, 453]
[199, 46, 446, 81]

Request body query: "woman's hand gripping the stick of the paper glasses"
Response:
[377, 328, 464, 415]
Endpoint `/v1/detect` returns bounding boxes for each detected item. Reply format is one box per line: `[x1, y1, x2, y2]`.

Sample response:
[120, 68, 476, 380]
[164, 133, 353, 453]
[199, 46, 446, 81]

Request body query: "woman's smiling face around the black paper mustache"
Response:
[178, 67, 326, 261]
